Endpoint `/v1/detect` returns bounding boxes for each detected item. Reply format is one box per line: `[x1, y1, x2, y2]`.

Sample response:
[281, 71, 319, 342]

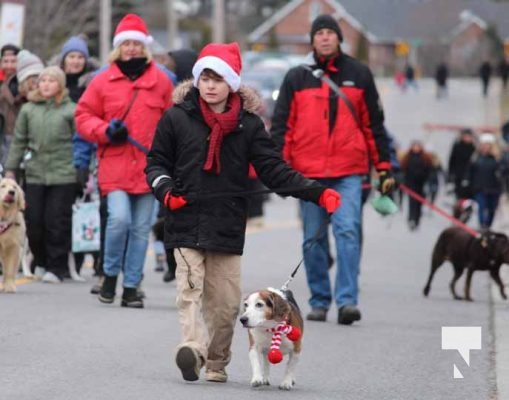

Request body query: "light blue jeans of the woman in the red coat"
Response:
[104, 190, 154, 288]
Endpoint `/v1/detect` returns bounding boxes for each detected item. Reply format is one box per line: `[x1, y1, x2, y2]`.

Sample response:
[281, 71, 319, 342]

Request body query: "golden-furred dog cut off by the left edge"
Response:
[0, 178, 26, 293]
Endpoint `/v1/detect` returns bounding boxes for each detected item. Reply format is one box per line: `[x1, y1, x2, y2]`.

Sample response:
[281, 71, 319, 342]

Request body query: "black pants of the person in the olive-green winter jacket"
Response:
[25, 183, 76, 278]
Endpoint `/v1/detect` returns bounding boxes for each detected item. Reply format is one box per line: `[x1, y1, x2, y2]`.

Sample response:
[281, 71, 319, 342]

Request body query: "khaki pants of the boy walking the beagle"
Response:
[174, 248, 241, 371]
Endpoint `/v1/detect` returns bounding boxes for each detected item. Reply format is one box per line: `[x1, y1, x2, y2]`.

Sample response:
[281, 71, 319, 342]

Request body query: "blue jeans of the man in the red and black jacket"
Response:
[300, 175, 362, 309]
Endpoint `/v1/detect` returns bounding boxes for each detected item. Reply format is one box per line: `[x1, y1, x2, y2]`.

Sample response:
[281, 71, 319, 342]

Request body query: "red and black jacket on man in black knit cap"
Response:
[272, 54, 391, 178]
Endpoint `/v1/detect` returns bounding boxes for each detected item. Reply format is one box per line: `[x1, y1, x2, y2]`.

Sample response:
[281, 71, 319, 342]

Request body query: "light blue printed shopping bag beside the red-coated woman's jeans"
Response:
[72, 201, 101, 253]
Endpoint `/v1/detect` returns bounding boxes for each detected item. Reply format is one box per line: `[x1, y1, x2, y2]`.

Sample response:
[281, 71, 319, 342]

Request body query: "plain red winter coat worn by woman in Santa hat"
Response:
[75, 62, 173, 195]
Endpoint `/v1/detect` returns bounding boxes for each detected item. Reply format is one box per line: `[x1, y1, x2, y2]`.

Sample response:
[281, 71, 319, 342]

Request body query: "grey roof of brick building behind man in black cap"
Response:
[249, 0, 509, 42]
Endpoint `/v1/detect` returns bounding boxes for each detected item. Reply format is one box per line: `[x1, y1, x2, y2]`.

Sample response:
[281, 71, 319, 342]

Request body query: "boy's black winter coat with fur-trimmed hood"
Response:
[145, 81, 325, 254]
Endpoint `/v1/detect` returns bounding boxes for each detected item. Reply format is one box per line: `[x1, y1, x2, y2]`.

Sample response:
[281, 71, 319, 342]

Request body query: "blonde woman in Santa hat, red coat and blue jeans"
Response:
[76, 14, 173, 308]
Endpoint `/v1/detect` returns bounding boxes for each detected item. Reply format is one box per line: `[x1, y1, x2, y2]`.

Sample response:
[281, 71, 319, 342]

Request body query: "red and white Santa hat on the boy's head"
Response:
[193, 42, 242, 92]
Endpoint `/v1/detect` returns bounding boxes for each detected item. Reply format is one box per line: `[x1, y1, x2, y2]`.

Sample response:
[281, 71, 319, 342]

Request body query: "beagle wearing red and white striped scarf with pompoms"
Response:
[240, 288, 303, 390]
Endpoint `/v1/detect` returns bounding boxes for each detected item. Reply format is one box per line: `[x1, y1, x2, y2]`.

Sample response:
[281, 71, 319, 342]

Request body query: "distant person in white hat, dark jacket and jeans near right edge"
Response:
[468, 133, 502, 229]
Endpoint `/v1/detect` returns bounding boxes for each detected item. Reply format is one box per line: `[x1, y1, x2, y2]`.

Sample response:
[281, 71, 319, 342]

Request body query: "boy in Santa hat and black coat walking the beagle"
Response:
[146, 43, 340, 382]
